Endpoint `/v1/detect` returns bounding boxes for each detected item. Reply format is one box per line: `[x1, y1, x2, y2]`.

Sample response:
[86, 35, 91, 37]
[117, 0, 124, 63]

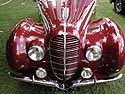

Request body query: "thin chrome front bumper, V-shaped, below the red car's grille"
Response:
[9, 73, 123, 90]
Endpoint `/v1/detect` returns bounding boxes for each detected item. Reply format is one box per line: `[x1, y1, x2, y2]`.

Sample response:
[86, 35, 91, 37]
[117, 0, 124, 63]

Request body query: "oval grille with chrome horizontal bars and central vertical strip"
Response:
[50, 35, 79, 81]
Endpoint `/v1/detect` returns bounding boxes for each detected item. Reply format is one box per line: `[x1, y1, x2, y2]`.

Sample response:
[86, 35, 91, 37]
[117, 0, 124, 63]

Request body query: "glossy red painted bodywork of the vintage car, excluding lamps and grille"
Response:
[6, 0, 125, 89]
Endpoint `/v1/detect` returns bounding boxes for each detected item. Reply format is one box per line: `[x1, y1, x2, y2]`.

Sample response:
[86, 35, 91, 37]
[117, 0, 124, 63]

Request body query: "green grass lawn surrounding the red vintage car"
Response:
[0, 0, 125, 94]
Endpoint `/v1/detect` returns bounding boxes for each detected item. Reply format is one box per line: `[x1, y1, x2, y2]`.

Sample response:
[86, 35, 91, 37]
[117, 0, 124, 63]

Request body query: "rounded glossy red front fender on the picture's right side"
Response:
[85, 18, 125, 75]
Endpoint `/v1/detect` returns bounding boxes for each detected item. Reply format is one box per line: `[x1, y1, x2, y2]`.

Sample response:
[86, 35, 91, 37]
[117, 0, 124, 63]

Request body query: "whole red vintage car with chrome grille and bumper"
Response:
[6, 0, 125, 90]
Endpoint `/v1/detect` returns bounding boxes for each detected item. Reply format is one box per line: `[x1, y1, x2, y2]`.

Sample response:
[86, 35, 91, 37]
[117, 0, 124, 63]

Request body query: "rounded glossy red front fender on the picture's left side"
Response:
[6, 19, 46, 72]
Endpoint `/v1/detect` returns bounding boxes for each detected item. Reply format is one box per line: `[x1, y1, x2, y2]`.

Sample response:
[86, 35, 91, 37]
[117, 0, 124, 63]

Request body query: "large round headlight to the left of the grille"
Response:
[28, 46, 44, 61]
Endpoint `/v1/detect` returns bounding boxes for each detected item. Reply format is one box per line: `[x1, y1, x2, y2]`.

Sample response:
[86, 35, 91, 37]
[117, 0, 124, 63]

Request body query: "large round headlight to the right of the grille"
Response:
[86, 46, 102, 61]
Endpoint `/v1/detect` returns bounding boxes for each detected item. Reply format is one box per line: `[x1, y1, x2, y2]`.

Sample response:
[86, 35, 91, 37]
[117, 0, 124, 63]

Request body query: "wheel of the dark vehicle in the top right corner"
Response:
[114, 0, 124, 13]
